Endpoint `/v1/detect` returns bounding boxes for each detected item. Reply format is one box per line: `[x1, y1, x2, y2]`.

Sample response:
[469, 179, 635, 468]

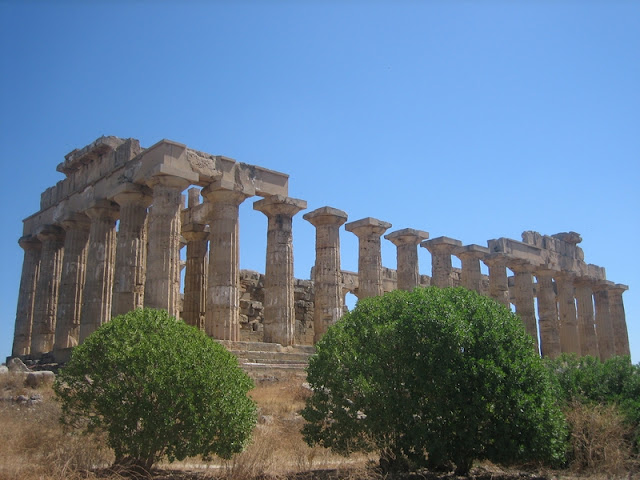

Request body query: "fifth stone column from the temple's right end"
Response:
[535, 268, 562, 358]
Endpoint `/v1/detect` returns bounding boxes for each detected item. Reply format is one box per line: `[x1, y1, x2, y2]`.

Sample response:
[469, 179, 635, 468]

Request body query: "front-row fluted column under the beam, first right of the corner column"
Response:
[201, 186, 250, 341]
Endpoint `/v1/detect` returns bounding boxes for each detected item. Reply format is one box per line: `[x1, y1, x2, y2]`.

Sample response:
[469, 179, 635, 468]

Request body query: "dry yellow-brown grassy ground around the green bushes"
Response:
[0, 375, 640, 480]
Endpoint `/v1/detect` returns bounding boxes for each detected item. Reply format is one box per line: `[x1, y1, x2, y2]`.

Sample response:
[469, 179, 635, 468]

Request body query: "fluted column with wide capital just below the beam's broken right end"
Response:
[253, 195, 307, 346]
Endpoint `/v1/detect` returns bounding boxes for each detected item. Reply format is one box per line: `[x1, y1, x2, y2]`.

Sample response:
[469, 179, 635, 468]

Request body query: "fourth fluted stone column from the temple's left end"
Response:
[79, 200, 118, 343]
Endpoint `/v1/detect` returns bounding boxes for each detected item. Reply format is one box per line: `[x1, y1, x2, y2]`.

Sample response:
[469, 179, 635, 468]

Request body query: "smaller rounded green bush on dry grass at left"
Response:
[54, 309, 256, 471]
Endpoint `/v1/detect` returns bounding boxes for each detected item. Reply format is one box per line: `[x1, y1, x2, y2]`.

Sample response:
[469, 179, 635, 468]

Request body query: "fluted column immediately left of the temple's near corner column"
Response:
[111, 183, 151, 317]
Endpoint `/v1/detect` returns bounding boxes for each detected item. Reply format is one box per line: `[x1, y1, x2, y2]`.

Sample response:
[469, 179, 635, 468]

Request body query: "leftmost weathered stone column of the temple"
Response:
[11, 235, 42, 356]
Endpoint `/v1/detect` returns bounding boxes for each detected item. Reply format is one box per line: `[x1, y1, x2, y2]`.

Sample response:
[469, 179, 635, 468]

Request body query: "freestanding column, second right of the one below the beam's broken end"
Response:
[344, 217, 391, 298]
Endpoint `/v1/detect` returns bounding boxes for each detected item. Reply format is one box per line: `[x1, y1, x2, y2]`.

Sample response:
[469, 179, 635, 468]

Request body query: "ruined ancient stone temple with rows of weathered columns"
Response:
[13, 137, 629, 361]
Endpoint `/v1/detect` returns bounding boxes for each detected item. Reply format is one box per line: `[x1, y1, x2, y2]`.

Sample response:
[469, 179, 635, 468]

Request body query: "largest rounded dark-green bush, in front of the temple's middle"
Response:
[302, 287, 566, 474]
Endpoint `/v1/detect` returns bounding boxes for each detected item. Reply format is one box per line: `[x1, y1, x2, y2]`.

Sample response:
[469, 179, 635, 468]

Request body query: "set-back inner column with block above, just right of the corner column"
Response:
[182, 188, 209, 331]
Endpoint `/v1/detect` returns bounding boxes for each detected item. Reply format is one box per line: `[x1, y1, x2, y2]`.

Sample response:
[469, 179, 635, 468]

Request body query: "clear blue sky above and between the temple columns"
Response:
[0, 0, 640, 363]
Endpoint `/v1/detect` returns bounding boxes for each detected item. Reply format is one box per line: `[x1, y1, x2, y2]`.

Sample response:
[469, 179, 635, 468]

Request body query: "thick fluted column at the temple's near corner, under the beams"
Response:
[144, 175, 190, 318]
